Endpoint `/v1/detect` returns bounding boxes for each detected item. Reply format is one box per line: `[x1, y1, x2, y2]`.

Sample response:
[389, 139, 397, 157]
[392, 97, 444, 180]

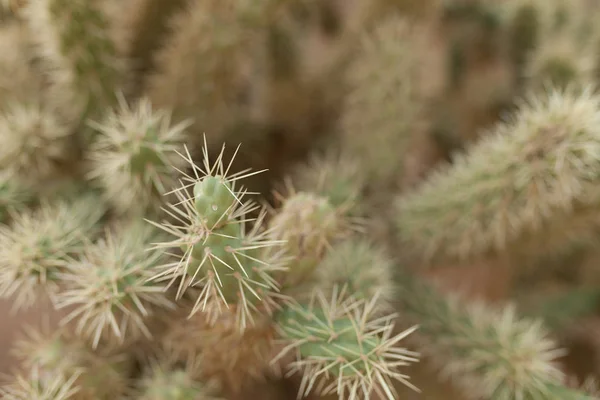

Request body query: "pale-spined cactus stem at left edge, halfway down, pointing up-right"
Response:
[0, 196, 104, 309]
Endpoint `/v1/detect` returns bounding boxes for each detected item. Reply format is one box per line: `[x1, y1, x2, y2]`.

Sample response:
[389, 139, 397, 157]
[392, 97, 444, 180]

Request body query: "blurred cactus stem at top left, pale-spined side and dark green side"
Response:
[23, 0, 125, 120]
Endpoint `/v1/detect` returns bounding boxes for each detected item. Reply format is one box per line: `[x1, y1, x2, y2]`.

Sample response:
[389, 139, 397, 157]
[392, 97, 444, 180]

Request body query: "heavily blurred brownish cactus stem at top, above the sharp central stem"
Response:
[146, 0, 262, 141]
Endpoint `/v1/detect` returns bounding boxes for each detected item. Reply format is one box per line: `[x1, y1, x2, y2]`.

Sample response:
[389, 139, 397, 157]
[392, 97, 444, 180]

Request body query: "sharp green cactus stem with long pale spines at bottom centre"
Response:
[274, 290, 418, 400]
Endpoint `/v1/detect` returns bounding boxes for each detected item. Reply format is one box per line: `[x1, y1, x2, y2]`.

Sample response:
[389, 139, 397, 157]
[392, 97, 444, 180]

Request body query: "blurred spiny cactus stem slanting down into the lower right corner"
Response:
[395, 269, 586, 400]
